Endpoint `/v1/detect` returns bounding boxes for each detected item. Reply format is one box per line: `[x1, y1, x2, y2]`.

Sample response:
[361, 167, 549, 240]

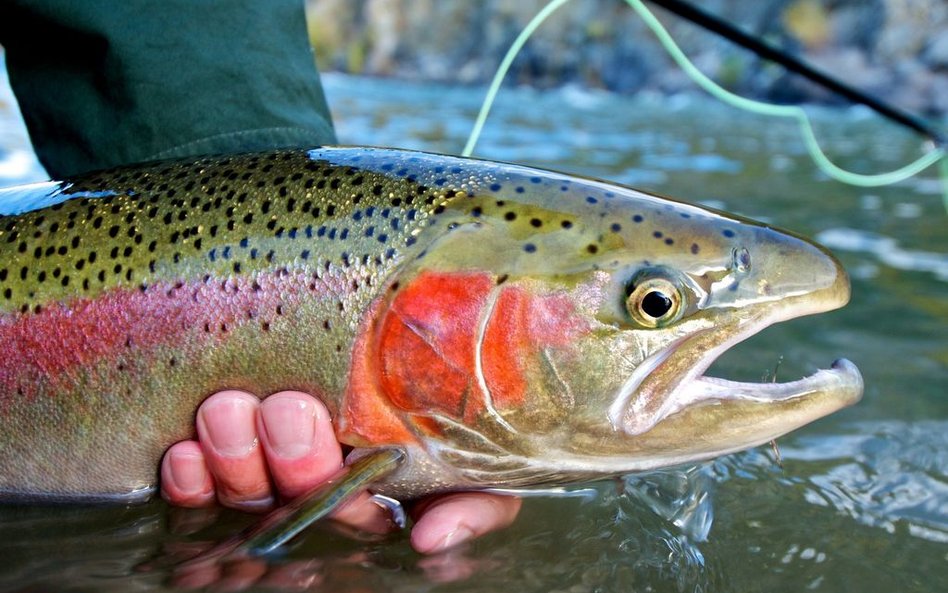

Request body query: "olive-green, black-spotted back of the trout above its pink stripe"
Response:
[0, 153, 435, 311]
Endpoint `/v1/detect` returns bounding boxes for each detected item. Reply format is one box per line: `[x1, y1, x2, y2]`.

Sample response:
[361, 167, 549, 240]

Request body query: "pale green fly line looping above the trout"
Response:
[461, 0, 948, 210]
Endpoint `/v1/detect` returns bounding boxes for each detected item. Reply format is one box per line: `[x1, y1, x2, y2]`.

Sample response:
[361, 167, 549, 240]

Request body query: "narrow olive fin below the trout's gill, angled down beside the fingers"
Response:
[178, 449, 405, 566]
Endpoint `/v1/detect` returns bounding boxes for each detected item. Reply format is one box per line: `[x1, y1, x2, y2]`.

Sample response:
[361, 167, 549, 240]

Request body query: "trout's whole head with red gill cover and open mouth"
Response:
[338, 157, 862, 487]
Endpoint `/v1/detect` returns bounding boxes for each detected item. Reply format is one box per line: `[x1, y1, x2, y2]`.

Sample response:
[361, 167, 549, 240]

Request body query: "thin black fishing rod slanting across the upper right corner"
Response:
[647, 0, 948, 147]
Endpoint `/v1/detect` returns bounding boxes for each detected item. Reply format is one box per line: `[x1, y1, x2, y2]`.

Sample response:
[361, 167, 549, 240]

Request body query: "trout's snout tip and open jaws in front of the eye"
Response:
[609, 223, 863, 462]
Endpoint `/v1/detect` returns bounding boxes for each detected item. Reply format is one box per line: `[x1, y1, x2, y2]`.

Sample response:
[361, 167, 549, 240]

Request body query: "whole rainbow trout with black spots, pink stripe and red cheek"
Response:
[0, 148, 862, 508]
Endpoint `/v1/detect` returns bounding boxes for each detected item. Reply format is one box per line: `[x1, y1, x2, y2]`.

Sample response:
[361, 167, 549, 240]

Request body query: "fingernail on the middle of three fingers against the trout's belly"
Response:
[198, 399, 257, 457]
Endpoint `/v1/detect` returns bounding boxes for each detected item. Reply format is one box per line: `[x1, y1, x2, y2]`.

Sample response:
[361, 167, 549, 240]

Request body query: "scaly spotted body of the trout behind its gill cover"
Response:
[0, 152, 466, 496]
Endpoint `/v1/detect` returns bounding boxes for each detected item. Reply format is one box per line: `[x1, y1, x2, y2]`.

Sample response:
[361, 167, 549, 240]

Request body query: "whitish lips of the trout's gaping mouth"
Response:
[609, 307, 863, 446]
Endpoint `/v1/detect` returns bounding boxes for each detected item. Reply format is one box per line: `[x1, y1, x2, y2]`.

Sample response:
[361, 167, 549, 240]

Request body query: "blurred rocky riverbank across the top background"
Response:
[307, 0, 948, 117]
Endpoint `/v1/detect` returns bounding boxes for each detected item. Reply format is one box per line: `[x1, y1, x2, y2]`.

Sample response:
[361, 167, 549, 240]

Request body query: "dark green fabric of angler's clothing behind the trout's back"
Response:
[0, 0, 335, 178]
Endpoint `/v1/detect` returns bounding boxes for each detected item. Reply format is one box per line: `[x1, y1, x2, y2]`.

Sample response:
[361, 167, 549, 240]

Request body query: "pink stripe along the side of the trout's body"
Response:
[0, 269, 346, 402]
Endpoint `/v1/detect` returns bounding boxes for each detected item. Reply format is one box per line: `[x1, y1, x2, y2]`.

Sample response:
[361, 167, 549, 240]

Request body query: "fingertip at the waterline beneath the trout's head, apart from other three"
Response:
[411, 492, 521, 554]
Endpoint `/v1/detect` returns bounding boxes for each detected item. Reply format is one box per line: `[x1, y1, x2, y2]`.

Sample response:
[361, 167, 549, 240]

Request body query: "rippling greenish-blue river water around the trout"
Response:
[0, 70, 948, 593]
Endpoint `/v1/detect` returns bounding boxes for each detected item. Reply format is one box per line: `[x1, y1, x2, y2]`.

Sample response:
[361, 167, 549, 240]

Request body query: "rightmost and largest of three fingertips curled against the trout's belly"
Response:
[257, 391, 342, 499]
